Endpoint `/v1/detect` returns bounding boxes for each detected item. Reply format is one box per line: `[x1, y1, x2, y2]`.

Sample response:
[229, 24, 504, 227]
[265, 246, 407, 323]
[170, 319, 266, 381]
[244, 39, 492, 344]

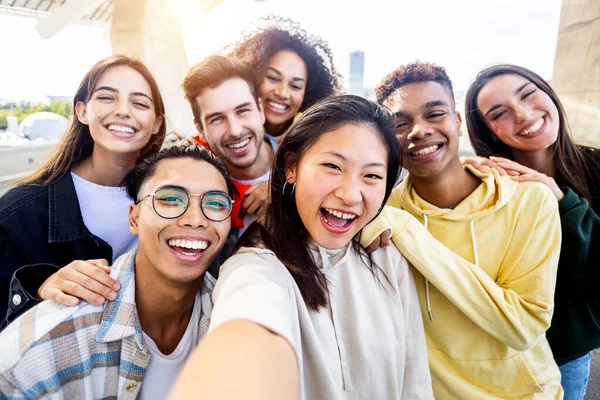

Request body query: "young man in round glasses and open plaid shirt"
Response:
[0, 146, 235, 400]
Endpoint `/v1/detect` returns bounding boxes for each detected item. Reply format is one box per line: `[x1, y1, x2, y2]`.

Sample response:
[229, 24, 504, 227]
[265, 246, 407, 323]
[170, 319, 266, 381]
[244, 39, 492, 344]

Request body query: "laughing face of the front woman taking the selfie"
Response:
[286, 124, 388, 249]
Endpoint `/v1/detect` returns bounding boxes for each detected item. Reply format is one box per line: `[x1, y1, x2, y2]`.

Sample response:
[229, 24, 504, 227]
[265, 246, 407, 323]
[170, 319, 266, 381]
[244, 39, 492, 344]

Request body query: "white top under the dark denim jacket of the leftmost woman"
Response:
[71, 172, 138, 264]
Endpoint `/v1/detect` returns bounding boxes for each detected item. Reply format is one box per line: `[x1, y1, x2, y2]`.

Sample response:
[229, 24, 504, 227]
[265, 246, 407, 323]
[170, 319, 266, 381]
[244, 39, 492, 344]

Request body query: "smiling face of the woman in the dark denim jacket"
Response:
[75, 66, 162, 155]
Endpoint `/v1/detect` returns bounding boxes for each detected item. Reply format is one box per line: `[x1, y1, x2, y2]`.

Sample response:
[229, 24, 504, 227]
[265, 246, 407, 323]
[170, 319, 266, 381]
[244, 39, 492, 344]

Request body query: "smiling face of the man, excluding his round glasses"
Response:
[129, 158, 231, 283]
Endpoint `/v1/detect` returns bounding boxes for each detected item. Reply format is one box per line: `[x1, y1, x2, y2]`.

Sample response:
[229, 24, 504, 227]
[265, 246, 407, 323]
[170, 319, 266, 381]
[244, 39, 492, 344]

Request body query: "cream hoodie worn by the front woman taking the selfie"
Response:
[209, 246, 433, 400]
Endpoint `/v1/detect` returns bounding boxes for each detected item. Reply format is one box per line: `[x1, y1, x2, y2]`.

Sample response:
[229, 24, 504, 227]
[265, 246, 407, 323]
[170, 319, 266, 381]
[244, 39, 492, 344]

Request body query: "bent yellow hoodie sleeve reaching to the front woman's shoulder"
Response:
[393, 190, 561, 351]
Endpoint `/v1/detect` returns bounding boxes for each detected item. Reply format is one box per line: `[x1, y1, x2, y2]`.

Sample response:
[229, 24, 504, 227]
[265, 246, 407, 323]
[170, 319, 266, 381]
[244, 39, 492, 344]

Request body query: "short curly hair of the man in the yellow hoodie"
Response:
[375, 61, 455, 104]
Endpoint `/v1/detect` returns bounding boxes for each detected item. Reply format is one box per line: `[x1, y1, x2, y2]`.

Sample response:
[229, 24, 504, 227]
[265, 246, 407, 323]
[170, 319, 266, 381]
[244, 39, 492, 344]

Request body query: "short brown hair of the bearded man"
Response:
[181, 54, 258, 123]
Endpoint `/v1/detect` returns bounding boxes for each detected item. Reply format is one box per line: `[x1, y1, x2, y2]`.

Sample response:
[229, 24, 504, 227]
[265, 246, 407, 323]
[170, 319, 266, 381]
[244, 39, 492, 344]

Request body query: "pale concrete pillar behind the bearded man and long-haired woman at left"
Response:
[110, 0, 196, 136]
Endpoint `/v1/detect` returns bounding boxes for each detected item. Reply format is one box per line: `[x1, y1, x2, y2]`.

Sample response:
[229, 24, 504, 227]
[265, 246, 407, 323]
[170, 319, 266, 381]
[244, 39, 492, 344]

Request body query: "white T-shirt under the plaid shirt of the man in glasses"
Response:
[138, 292, 202, 400]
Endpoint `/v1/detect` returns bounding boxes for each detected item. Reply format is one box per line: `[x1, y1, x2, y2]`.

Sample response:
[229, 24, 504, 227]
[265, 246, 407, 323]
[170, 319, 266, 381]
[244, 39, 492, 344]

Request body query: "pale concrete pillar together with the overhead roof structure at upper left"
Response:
[0, 0, 223, 135]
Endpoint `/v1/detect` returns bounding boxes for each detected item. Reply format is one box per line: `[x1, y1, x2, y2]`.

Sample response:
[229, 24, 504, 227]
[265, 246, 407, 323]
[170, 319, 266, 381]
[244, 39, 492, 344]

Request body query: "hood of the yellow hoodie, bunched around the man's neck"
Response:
[391, 165, 518, 221]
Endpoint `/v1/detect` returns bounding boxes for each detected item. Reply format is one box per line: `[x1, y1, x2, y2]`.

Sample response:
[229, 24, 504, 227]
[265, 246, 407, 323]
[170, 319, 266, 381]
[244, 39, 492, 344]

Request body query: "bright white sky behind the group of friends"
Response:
[0, 0, 561, 100]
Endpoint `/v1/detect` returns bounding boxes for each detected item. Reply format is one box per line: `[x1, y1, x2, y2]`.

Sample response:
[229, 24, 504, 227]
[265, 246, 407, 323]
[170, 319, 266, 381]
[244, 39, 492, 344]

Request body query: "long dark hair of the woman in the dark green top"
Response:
[465, 64, 598, 203]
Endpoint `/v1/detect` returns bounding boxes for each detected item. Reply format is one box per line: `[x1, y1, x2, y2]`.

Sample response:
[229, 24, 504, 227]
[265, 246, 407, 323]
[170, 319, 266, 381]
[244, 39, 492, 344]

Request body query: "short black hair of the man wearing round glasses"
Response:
[122, 145, 237, 202]
